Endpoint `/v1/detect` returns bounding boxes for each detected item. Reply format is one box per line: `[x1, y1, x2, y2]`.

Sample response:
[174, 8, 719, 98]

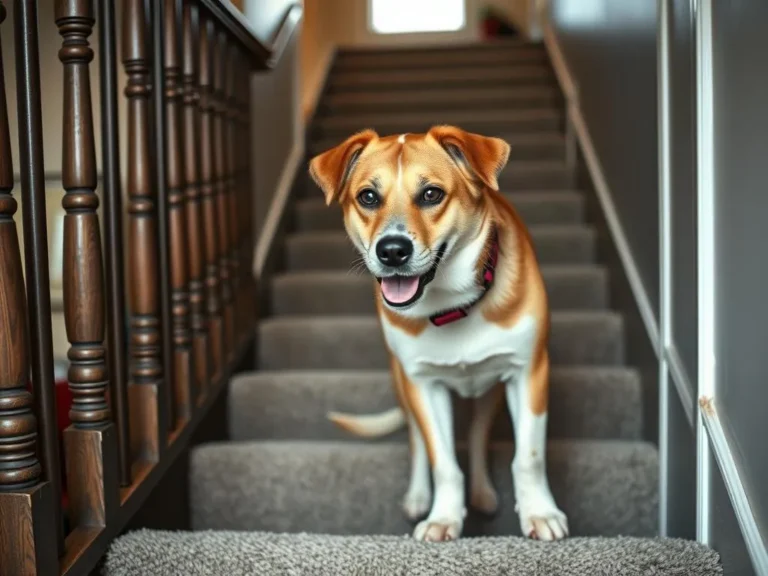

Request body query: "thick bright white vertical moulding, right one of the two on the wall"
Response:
[693, 0, 717, 544]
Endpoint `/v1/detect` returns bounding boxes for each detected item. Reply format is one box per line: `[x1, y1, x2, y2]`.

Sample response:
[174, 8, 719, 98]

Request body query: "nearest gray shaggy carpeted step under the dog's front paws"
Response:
[102, 530, 722, 576]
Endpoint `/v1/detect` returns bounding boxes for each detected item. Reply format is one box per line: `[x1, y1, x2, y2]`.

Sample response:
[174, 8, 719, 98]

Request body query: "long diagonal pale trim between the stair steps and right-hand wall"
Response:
[542, 21, 661, 354]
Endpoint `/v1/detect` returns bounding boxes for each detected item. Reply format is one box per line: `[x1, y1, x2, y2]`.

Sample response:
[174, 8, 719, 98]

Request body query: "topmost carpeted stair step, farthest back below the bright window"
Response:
[333, 46, 547, 72]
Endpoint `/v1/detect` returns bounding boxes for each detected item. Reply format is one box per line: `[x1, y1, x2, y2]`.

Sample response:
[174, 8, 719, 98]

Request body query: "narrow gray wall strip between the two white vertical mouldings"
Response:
[666, 0, 698, 538]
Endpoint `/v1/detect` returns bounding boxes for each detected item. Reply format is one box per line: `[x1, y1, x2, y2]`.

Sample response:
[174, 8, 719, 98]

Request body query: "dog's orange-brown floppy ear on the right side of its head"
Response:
[429, 126, 509, 190]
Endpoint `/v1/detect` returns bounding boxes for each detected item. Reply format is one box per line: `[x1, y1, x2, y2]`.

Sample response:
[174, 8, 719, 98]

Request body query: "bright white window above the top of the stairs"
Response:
[369, 0, 466, 34]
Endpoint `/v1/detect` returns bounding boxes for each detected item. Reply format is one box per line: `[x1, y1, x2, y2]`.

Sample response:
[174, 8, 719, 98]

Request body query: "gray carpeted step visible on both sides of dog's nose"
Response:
[285, 226, 596, 272]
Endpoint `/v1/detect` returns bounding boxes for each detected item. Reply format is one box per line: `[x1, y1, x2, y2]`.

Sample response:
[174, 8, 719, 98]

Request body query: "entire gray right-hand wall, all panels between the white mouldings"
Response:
[550, 0, 768, 575]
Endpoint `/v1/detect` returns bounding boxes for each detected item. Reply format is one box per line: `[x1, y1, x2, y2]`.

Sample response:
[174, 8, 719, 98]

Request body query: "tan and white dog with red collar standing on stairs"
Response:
[310, 126, 568, 541]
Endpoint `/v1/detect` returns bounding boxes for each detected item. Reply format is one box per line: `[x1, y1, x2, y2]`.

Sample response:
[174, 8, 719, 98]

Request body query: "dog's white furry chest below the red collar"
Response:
[384, 314, 536, 398]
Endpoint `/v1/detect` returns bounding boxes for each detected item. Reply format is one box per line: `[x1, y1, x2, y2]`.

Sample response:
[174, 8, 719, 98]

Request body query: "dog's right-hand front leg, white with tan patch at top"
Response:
[507, 350, 568, 540]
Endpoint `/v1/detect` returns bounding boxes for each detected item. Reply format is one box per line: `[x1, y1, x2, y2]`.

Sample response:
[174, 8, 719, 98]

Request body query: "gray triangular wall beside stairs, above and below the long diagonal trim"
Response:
[549, 0, 659, 441]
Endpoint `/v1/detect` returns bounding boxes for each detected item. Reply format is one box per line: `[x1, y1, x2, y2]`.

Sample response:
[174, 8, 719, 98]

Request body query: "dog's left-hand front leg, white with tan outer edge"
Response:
[405, 381, 466, 542]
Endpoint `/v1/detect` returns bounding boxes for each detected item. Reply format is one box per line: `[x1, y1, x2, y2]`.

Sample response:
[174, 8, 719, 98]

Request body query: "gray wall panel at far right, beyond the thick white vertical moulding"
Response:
[712, 1, 768, 564]
